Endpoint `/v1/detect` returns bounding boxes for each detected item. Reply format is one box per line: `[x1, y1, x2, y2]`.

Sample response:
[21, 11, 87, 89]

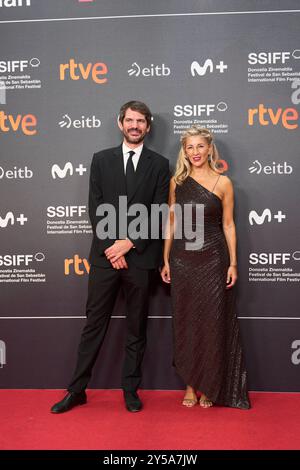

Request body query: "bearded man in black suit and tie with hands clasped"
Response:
[51, 101, 170, 413]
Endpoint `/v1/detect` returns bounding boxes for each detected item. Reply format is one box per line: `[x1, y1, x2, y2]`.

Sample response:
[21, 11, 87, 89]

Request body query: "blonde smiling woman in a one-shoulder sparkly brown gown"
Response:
[161, 126, 250, 409]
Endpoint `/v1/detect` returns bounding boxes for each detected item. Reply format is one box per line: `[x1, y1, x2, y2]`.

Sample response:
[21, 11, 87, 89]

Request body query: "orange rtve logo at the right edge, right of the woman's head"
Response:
[248, 103, 299, 130]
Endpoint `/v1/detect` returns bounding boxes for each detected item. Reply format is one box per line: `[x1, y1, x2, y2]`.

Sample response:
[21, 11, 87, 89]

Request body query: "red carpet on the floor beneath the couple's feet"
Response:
[0, 390, 300, 450]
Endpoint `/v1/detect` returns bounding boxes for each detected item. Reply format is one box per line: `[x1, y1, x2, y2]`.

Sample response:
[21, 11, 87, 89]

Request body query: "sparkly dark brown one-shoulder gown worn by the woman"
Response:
[170, 176, 250, 409]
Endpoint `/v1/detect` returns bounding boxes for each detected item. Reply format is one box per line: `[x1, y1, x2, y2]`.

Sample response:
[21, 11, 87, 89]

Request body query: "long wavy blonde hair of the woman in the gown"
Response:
[174, 126, 220, 184]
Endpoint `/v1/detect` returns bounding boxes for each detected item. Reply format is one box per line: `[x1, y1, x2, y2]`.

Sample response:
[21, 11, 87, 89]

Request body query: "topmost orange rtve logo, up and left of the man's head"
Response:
[59, 59, 108, 85]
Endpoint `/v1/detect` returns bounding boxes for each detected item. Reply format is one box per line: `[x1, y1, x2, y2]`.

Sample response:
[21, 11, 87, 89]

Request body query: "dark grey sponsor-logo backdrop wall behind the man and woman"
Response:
[0, 0, 300, 391]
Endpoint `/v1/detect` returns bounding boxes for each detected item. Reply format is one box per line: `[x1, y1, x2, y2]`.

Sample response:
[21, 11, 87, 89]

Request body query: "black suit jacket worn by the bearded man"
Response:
[89, 145, 170, 269]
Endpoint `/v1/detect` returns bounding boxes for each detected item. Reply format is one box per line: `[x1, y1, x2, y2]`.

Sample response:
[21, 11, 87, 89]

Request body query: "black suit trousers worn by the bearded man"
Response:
[68, 264, 151, 393]
